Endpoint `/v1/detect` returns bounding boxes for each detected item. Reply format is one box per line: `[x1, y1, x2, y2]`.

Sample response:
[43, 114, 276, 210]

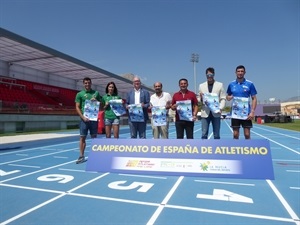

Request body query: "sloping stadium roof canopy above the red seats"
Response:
[0, 28, 154, 93]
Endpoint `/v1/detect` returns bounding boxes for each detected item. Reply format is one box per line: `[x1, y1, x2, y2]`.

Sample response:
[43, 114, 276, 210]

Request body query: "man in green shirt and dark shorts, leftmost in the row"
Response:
[75, 77, 102, 164]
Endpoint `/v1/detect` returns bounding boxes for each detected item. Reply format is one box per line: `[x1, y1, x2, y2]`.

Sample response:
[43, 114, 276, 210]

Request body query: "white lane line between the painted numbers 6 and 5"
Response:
[1, 173, 109, 225]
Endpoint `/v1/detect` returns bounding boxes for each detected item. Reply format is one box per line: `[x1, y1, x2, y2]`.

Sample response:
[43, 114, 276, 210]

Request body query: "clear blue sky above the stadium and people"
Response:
[0, 0, 300, 102]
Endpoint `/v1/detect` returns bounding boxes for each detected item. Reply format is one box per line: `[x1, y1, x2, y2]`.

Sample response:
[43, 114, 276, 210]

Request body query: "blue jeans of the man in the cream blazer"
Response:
[201, 112, 221, 139]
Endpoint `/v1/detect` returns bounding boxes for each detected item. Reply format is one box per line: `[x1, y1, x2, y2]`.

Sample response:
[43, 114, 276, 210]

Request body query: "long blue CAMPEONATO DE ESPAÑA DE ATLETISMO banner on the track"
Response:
[86, 138, 274, 180]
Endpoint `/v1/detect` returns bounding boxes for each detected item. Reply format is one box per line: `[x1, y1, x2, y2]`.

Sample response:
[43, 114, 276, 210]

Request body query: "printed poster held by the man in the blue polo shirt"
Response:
[231, 97, 249, 120]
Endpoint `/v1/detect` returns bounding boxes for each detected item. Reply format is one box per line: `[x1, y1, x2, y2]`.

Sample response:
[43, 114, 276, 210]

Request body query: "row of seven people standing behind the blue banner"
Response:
[75, 65, 257, 163]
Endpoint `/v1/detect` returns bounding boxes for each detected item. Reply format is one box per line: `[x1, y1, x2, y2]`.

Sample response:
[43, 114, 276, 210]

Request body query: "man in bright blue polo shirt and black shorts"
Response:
[226, 65, 257, 139]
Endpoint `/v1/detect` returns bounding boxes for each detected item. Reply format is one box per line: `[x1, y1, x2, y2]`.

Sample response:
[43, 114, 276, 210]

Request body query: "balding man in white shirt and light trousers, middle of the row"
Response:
[149, 82, 172, 139]
